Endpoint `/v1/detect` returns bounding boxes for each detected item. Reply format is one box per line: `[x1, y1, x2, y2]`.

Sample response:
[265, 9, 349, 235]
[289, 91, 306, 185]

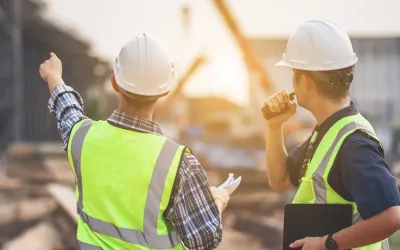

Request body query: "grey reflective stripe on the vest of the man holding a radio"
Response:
[312, 122, 390, 250]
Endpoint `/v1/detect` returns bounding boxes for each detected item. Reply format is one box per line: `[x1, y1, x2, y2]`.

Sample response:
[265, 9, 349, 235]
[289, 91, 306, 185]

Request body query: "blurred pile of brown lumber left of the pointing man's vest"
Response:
[0, 144, 77, 250]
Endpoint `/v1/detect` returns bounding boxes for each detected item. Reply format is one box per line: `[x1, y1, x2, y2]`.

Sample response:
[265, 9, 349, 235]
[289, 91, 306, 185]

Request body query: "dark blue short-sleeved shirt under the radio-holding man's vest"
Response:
[286, 103, 400, 219]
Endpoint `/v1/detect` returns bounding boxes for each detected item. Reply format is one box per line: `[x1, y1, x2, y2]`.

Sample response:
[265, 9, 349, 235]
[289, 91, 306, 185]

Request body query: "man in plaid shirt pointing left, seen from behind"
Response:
[39, 34, 229, 250]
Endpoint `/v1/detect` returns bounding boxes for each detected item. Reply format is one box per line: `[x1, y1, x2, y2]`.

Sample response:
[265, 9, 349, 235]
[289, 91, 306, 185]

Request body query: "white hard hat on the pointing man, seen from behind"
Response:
[113, 34, 174, 96]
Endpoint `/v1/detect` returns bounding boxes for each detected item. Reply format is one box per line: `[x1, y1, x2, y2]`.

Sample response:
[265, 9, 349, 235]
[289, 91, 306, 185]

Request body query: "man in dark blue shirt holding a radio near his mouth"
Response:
[264, 20, 400, 250]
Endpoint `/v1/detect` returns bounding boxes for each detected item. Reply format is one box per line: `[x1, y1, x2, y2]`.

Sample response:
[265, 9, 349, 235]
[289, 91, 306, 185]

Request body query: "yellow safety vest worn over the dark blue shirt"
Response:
[293, 114, 390, 250]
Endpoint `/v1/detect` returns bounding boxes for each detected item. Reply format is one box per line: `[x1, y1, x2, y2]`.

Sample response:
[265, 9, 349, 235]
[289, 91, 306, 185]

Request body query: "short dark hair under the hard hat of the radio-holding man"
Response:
[295, 66, 354, 100]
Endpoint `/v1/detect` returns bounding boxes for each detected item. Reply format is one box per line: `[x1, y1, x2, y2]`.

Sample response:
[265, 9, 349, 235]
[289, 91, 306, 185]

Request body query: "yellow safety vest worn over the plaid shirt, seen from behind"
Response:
[68, 120, 185, 250]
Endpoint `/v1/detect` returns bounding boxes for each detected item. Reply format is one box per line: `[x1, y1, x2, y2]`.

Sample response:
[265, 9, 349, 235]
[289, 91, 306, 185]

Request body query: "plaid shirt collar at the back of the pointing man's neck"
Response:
[107, 110, 164, 136]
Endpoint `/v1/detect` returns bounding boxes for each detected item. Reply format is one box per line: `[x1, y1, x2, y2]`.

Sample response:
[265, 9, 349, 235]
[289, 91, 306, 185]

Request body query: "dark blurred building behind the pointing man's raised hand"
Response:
[0, 0, 110, 150]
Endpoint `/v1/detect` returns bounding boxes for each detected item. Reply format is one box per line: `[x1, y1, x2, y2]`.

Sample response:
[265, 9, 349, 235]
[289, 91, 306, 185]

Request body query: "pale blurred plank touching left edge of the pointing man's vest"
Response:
[47, 183, 77, 223]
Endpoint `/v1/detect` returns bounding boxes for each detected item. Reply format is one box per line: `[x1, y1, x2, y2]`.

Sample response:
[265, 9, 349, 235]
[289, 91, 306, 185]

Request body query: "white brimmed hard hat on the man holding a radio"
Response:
[275, 20, 358, 71]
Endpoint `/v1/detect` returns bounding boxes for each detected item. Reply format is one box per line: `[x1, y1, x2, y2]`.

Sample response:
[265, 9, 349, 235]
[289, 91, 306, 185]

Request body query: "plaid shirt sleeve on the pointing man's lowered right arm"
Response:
[164, 153, 222, 250]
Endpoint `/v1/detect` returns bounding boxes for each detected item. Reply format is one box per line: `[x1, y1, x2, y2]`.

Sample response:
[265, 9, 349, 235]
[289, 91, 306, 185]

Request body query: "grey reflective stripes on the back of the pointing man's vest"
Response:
[71, 120, 180, 250]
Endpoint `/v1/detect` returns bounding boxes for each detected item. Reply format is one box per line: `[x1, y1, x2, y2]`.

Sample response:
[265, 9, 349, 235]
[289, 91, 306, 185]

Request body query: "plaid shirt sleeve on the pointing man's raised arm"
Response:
[48, 85, 86, 151]
